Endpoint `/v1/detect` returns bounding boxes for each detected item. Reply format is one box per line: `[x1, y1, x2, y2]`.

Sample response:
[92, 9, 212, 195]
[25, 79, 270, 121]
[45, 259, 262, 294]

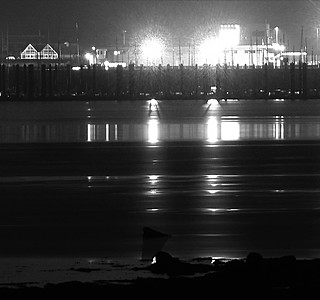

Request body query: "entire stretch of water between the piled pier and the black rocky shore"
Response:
[0, 100, 320, 257]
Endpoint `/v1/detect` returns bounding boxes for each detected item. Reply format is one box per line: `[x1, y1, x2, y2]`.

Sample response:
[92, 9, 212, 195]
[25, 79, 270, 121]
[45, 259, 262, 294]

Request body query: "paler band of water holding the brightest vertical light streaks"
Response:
[0, 116, 320, 144]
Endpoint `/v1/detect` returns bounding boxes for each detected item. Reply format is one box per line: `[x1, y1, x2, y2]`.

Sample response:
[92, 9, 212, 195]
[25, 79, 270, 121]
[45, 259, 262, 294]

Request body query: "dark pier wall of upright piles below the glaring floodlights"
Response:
[0, 63, 320, 100]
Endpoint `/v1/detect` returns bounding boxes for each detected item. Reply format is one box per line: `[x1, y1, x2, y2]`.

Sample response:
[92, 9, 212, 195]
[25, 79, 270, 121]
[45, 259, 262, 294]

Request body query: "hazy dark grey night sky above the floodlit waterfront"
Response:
[0, 0, 320, 47]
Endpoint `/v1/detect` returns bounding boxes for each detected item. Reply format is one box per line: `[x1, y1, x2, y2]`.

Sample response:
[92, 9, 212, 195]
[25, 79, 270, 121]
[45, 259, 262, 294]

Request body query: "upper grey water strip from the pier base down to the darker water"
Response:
[0, 100, 320, 143]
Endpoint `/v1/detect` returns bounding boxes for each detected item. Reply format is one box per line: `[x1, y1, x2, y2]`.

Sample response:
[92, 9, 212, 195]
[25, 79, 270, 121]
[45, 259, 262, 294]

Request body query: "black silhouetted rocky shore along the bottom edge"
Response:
[0, 252, 320, 299]
